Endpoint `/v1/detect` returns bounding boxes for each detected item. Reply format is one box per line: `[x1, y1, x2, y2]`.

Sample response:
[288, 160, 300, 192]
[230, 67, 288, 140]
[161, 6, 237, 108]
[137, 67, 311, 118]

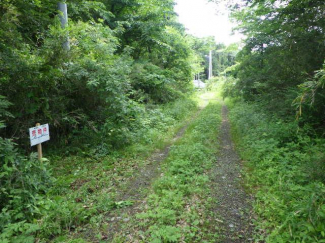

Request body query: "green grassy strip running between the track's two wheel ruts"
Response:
[128, 101, 221, 242]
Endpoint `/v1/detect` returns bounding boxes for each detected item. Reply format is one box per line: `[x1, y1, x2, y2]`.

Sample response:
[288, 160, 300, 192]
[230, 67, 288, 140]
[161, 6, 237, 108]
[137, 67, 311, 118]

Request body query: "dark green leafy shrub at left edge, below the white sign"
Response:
[0, 138, 51, 242]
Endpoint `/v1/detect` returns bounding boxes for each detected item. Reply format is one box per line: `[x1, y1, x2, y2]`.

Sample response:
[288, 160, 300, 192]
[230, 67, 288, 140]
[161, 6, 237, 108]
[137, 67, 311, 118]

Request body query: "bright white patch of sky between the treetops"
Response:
[175, 0, 241, 45]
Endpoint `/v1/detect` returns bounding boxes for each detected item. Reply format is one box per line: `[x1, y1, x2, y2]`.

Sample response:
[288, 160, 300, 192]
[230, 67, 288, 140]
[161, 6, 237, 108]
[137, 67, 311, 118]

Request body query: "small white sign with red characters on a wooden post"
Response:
[29, 123, 50, 161]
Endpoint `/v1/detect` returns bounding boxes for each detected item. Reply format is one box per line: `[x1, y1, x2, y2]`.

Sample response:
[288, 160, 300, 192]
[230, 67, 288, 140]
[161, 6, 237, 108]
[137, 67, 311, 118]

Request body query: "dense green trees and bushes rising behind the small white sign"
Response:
[0, 0, 195, 148]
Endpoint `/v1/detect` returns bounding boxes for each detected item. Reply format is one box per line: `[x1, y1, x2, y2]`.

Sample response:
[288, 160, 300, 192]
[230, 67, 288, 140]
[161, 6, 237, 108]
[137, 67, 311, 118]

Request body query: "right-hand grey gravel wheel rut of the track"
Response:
[211, 106, 253, 243]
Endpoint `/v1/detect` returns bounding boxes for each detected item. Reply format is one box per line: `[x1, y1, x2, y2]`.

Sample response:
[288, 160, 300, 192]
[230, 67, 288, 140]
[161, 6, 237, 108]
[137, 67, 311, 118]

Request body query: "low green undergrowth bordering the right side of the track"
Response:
[230, 99, 325, 243]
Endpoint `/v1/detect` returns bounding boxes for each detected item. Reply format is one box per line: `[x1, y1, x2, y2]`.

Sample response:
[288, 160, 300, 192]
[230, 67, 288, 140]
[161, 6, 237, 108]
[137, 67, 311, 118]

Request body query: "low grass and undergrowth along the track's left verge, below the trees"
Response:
[0, 99, 197, 243]
